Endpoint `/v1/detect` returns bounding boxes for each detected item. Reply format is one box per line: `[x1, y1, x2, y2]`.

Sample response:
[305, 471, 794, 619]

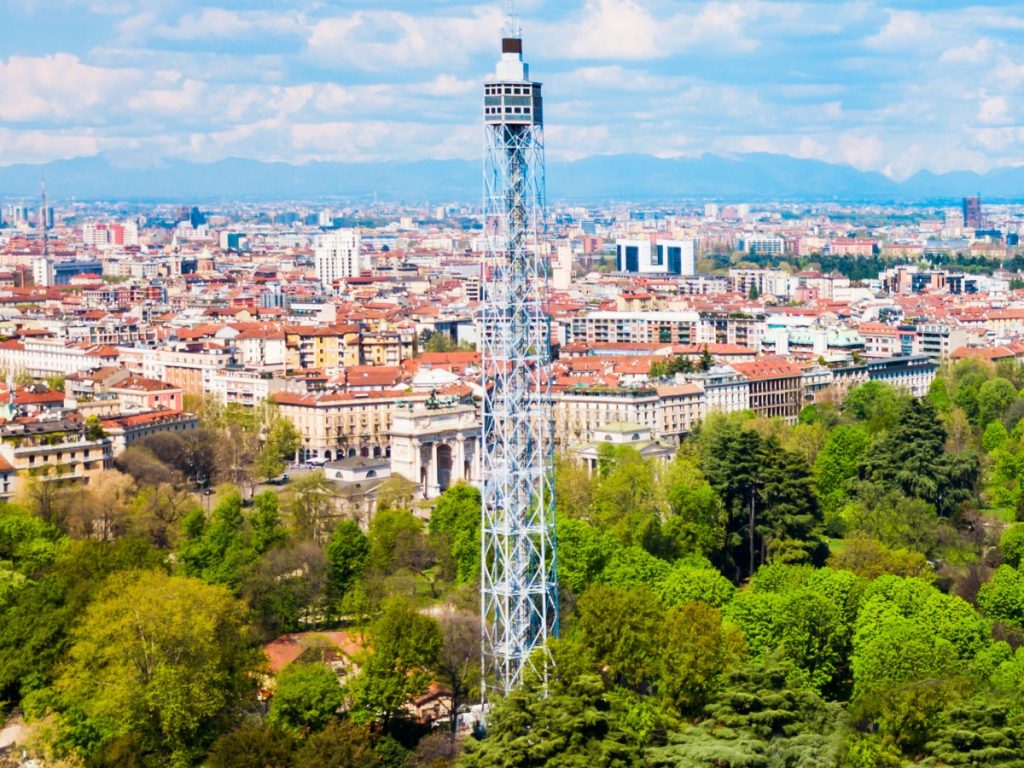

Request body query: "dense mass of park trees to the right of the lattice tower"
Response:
[473, 361, 1024, 768]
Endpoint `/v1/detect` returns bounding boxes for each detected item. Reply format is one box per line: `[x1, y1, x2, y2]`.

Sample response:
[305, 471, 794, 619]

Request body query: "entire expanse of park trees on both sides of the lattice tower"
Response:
[6, 361, 1024, 768]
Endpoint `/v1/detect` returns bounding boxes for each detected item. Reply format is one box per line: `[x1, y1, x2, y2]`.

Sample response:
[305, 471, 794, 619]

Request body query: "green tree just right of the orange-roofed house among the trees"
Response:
[349, 597, 443, 725]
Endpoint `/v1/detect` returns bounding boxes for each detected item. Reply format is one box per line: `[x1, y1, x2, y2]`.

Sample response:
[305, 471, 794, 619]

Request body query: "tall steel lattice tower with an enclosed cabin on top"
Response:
[480, 20, 558, 698]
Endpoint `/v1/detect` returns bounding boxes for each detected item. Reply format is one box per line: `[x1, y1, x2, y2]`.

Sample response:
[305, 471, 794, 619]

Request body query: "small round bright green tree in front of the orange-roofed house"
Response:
[267, 664, 345, 734]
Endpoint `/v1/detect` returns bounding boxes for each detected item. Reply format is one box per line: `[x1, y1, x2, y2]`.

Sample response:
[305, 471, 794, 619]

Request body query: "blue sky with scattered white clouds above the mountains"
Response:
[0, 0, 1024, 178]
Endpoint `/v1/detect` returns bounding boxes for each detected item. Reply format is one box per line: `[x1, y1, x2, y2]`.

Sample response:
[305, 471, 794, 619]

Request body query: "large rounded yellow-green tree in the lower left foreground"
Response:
[53, 571, 259, 766]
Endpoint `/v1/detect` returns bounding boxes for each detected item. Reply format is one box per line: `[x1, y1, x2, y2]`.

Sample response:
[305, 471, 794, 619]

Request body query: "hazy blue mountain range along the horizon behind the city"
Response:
[0, 154, 1024, 203]
